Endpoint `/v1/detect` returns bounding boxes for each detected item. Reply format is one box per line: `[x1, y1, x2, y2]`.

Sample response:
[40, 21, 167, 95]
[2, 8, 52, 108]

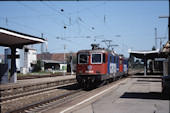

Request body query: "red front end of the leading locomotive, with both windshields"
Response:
[76, 50, 107, 87]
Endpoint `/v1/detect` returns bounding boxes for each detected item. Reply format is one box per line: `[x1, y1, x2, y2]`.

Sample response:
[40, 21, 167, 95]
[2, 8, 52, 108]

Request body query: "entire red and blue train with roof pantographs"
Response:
[76, 44, 128, 88]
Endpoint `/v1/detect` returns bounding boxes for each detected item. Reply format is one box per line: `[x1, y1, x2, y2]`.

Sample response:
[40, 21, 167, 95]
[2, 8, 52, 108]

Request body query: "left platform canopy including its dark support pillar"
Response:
[0, 27, 45, 83]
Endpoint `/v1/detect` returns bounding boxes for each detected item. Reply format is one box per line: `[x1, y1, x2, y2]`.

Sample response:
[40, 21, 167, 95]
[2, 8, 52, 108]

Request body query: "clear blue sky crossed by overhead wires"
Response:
[0, 0, 169, 57]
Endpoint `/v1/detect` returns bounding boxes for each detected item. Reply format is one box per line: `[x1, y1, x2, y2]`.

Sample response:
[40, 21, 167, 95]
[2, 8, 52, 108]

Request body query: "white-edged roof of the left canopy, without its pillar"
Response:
[0, 27, 45, 48]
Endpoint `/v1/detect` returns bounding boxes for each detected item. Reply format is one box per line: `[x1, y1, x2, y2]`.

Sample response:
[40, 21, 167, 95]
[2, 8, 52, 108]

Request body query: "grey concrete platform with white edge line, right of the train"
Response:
[46, 75, 170, 113]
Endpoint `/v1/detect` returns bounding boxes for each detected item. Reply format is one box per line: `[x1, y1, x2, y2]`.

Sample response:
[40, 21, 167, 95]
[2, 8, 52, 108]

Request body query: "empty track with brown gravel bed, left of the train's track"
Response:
[0, 83, 80, 113]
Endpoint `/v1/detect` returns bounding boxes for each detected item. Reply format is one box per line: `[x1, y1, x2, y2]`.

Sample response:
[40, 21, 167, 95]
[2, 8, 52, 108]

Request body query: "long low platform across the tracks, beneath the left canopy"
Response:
[0, 75, 76, 95]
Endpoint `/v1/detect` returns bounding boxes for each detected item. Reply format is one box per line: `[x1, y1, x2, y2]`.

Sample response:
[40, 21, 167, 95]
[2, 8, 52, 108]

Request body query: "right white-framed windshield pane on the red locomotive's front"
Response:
[91, 53, 102, 64]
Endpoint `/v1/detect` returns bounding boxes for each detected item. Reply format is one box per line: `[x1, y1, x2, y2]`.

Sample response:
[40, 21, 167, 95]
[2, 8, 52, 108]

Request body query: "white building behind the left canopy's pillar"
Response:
[5, 46, 37, 74]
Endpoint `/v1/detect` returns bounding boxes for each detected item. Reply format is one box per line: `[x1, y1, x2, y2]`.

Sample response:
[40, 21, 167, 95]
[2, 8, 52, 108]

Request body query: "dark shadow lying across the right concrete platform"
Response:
[120, 92, 170, 100]
